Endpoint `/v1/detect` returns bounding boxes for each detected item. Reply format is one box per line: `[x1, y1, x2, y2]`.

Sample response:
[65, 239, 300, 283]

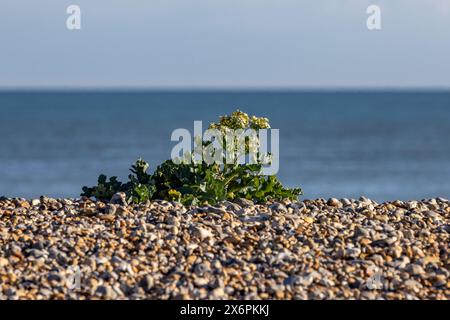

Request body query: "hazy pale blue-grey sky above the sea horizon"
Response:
[0, 0, 450, 88]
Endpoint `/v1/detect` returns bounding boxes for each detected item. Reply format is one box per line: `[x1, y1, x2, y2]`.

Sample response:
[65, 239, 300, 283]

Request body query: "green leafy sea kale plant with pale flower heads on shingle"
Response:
[81, 111, 302, 205]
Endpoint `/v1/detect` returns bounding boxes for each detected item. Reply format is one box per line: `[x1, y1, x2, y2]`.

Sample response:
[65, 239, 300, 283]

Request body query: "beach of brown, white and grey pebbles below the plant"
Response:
[0, 195, 450, 300]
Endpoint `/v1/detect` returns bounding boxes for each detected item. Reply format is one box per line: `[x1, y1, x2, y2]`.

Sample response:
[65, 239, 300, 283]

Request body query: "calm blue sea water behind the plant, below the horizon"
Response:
[0, 91, 450, 201]
